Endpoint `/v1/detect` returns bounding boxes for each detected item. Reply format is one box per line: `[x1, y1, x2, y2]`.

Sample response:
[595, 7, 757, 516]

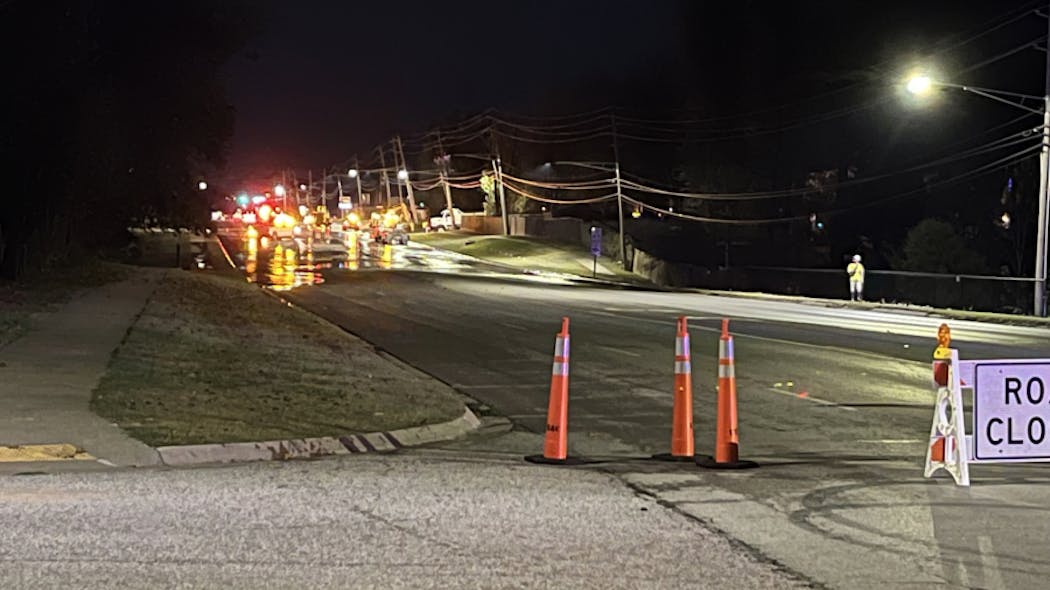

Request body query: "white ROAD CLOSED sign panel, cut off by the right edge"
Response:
[973, 361, 1050, 461]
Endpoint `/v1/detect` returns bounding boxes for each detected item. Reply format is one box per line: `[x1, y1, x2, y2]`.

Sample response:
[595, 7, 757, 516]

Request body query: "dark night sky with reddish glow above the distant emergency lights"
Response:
[222, 0, 681, 177]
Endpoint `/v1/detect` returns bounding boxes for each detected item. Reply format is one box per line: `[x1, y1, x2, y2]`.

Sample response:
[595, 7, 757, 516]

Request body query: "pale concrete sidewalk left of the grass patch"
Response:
[0, 269, 163, 466]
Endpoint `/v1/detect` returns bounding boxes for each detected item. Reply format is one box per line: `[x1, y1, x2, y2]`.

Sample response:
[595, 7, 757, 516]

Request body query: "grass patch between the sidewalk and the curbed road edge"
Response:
[91, 271, 464, 446]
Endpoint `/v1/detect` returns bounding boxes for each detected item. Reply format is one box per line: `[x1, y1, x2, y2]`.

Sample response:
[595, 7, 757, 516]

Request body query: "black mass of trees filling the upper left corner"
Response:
[0, 0, 256, 278]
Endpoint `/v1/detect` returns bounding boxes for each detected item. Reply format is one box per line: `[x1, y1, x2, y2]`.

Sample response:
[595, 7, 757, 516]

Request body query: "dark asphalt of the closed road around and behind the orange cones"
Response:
[217, 232, 1050, 588]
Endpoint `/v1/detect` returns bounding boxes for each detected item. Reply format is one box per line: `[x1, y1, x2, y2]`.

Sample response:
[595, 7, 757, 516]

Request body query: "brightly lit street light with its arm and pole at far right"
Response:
[905, 70, 1050, 317]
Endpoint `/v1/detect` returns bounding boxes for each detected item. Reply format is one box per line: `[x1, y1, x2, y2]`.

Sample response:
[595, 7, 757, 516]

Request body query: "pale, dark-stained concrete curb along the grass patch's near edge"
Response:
[156, 408, 481, 467]
